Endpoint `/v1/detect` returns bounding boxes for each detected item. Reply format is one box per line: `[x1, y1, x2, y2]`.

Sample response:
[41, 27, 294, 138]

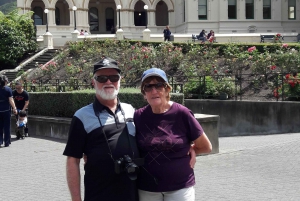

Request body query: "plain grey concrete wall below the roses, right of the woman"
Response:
[184, 99, 300, 137]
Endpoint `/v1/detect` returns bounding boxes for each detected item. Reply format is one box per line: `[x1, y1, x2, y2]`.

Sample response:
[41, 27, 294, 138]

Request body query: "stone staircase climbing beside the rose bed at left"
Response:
[4, 49, 56, 82]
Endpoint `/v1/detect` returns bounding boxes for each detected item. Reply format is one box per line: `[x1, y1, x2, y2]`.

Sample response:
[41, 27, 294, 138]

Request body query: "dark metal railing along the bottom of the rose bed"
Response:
[11, 73, 300, 101]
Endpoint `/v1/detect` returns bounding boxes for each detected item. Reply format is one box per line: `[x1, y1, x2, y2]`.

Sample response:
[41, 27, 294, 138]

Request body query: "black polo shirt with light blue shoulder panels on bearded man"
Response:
[63, 100, 138, 201]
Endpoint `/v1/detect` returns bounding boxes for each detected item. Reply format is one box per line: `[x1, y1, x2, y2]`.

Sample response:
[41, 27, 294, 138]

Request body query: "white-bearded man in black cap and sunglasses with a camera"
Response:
[63, 58, 138, 201]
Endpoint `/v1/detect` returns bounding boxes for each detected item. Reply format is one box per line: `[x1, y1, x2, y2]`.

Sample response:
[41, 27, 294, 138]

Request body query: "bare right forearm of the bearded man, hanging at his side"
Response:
[66, 156, 81, 201]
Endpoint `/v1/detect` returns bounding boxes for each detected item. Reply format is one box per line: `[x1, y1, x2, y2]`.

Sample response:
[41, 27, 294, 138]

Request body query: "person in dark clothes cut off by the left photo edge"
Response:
[0, 75, 17, 147]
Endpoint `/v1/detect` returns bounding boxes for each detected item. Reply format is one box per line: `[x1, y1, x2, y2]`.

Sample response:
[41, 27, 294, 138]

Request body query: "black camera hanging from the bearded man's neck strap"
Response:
[115, 155, 144, 180]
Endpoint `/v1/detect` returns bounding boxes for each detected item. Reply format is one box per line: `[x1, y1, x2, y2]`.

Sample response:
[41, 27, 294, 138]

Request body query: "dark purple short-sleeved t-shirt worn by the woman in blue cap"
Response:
[134, 102, 203, 192]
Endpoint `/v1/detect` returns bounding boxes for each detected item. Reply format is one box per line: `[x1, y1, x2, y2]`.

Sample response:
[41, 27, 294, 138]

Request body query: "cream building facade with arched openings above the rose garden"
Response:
[17, 0, 300, 44]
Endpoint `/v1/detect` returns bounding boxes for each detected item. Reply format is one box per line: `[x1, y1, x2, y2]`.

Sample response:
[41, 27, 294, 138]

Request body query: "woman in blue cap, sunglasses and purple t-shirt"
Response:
[134, 68, 212, 201]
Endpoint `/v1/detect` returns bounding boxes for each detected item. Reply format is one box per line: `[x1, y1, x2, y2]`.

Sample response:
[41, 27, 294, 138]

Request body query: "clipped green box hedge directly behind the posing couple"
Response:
[29, 89, 184, 117]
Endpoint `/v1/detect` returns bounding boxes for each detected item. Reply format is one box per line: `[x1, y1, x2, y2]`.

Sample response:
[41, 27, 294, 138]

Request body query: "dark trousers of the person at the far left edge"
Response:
[0, 111, 10, 145]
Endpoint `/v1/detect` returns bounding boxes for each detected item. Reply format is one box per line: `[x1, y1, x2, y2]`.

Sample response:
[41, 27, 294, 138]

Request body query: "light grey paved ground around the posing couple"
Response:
[0, 133, 300, 201]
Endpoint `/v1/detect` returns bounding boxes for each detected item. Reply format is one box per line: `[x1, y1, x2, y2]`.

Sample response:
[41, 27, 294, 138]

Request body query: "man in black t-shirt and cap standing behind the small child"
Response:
[13, 82, 29, 137]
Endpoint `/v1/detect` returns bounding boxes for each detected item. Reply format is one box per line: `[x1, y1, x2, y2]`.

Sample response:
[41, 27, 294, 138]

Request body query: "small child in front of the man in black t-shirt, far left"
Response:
[16, 110, 29, 139]
